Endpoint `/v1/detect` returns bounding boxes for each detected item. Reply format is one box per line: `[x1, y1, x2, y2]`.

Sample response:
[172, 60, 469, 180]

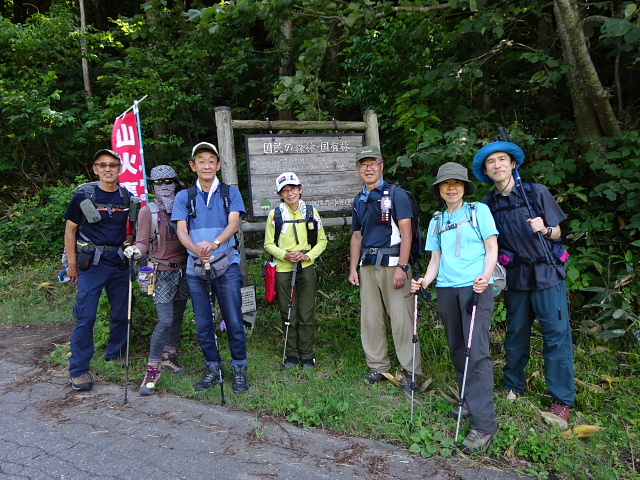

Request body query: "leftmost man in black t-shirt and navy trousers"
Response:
[64, 150, 131, 391]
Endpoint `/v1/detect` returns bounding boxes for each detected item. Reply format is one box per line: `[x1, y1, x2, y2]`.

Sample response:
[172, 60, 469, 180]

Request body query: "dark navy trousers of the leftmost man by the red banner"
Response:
[69, 263, 129, 378]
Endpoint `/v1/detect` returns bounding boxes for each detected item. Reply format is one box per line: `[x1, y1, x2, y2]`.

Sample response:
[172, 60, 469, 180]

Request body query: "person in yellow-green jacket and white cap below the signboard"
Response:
[264, 172, 327, 370]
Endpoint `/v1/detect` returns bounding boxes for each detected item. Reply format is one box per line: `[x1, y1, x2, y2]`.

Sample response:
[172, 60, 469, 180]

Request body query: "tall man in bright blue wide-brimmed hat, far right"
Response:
[473, 141, 575, 420]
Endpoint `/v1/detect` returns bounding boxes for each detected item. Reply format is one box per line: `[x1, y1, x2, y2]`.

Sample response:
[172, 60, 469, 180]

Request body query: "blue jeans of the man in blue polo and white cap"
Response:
[187, 263, 247, 365]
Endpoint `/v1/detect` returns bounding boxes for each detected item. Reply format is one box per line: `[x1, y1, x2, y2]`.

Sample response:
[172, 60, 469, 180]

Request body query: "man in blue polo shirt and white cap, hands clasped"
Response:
[171, 142, 249, 393]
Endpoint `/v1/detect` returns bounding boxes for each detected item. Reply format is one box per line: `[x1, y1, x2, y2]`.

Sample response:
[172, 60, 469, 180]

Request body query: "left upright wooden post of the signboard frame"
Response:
[214, 107, 248, 286]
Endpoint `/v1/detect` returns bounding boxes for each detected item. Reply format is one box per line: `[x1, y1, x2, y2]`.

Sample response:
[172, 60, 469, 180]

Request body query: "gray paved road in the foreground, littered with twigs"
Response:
[0, 361, 520, 480]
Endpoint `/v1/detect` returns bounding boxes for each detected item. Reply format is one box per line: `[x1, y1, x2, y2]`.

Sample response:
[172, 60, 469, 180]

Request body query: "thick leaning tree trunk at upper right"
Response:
[553, 0, 620, 138]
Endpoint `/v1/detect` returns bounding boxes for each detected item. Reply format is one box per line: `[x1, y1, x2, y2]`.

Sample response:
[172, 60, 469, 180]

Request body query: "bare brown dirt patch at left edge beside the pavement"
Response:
[0, 322, 74, 365]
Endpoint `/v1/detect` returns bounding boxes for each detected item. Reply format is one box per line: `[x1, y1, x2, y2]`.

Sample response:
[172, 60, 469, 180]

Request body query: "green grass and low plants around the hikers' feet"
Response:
[0, 231, 640, 480]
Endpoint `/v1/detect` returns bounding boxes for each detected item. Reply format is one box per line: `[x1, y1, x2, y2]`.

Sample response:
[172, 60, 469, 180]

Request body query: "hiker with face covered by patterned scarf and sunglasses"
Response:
[125, 165, 189, 395]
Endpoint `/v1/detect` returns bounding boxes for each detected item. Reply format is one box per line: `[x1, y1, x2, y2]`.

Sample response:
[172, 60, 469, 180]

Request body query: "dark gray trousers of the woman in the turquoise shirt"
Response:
[437, 287, 498, 433]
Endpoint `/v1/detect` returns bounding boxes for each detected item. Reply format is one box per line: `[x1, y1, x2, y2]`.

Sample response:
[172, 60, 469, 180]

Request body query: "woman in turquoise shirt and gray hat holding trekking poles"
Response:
[411, 162, 498, 454]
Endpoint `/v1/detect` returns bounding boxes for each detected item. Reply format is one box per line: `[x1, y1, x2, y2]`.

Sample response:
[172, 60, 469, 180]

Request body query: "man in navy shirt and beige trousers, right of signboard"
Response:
[349, 146, 422, 393]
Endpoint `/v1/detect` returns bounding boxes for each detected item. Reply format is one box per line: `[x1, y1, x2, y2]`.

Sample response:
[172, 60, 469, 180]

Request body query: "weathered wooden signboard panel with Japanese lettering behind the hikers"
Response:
[245, 133, 364, 218]
